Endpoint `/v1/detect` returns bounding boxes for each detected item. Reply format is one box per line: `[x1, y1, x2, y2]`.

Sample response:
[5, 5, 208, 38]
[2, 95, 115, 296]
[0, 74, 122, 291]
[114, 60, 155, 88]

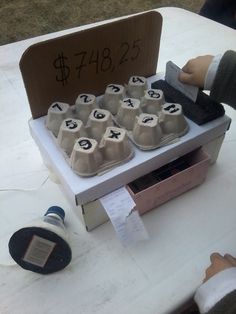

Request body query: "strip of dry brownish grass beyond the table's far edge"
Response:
[0, 0, 203, 45]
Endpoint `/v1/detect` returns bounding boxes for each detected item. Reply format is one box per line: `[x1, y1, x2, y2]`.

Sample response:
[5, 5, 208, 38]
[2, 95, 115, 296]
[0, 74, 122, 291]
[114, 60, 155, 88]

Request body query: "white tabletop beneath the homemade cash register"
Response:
[0, 8, 236, 314]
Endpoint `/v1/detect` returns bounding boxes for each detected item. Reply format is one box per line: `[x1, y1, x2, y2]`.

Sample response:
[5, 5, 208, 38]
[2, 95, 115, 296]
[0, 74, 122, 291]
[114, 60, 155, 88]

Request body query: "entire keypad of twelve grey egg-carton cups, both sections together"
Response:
[46, 76, 188, 176]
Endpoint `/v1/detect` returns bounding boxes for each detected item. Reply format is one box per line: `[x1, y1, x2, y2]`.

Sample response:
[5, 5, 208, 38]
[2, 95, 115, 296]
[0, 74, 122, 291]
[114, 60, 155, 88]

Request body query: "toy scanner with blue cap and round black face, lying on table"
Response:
[8, 206, 72, 274]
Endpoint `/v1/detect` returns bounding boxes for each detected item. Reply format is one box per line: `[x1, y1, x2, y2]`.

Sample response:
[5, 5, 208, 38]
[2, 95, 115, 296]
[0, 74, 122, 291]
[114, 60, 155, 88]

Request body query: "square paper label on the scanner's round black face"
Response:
[23, 235, 56, 267]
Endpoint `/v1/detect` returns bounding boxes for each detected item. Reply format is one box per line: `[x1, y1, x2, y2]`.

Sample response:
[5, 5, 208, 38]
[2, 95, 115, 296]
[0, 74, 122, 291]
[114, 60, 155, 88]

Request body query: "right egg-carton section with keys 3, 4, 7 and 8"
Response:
[99, 76, 189, 150]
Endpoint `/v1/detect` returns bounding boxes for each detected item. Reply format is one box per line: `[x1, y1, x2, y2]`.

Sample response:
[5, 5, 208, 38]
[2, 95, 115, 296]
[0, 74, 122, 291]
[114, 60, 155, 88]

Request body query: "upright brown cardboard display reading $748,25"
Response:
[20, 11, 162, 119]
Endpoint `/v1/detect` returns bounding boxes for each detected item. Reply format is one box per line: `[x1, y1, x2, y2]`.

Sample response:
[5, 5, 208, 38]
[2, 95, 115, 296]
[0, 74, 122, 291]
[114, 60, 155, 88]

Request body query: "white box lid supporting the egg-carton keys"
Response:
[29, 108, 230, 207]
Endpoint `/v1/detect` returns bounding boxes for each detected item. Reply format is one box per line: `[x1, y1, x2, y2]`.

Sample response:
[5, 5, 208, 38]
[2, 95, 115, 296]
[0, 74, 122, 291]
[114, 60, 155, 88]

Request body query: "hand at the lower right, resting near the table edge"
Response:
[203, 253, 236, 282]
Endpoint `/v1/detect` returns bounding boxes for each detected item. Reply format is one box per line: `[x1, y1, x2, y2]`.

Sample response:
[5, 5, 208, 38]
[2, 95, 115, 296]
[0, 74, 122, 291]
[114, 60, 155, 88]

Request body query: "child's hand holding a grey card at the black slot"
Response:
[179, 55, 214, 88]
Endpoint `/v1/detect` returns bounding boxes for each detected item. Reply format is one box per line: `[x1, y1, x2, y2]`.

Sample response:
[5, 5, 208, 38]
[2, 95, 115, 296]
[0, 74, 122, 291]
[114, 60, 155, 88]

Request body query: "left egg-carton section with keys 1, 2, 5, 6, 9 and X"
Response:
[46, 94, 134, 177]
